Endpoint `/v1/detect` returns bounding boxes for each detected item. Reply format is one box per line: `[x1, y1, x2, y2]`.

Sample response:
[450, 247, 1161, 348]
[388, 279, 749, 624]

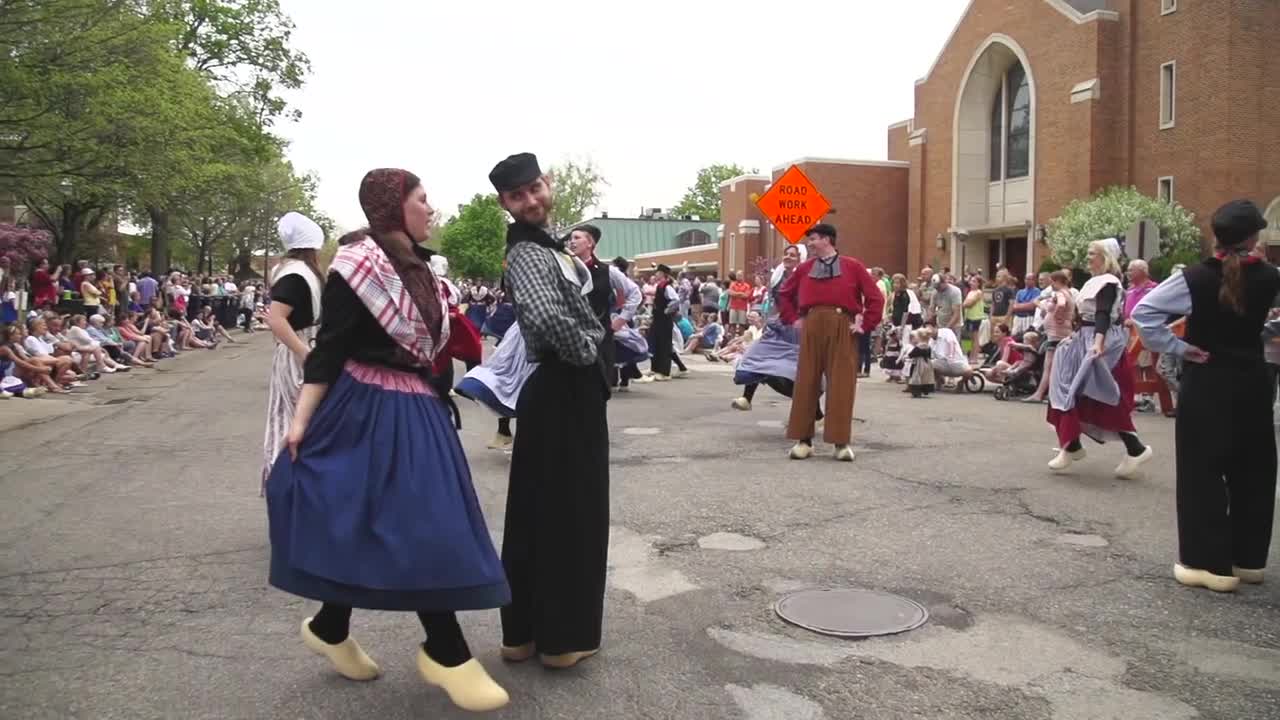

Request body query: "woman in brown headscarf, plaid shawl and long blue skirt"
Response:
[266, 169, 511, 710]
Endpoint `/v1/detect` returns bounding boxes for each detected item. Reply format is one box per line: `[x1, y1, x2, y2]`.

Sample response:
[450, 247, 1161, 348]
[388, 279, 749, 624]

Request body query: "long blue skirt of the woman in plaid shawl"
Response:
[266, 363, 511, 611]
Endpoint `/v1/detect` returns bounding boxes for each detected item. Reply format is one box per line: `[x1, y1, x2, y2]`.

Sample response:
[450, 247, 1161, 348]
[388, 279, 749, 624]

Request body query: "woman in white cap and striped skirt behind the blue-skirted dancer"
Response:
[259, 213, 324, 495]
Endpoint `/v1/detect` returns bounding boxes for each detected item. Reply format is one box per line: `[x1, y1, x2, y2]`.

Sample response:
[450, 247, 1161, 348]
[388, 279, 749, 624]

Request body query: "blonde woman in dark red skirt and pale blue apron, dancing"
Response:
[1048, 238, 1153, 479]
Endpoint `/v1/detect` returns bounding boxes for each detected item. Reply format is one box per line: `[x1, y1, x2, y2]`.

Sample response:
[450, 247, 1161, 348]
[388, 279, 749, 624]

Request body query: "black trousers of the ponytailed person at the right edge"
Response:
[1175, 363, 1276, 575]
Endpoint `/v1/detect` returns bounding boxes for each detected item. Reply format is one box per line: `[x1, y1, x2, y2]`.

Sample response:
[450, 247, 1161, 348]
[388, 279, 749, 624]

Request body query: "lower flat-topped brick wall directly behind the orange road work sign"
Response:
[773, 161, 919, 273]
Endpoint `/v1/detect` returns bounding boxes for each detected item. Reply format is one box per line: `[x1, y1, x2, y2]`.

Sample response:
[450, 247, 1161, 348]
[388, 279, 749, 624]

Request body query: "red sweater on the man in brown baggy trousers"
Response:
[778, 255, 884, 333]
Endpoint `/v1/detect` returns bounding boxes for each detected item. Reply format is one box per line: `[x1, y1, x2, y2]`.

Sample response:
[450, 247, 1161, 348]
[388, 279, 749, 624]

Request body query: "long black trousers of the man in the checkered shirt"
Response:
[502, 360, 609, 655]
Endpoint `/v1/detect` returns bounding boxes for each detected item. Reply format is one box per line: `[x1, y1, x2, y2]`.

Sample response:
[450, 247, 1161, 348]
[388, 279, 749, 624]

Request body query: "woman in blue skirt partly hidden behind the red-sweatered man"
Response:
[733, 245, 822, 423]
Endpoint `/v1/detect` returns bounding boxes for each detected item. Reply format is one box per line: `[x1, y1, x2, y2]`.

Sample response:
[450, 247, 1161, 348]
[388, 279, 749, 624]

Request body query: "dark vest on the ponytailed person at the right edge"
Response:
[1183, 258, 1280, 365]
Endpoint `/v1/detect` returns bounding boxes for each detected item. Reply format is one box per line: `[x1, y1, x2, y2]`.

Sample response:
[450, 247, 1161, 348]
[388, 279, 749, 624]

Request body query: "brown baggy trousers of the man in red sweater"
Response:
[787, 306, 858, 445]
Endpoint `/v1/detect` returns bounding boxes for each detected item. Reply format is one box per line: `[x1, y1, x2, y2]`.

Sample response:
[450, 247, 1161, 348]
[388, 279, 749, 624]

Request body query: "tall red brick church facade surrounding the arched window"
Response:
[888, 0, 1280, 269]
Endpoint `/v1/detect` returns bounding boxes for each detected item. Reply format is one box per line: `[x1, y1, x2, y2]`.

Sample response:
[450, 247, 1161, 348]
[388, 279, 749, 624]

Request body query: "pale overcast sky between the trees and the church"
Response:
[280, 0, 966, 228]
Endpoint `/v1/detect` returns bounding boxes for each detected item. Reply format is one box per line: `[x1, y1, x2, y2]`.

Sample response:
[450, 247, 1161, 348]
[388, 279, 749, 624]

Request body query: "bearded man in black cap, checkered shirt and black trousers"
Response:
[489, 152, 609, 667]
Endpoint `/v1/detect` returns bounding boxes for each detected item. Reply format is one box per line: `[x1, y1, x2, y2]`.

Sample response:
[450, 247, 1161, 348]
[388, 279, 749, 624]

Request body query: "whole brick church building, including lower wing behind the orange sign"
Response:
[719, 0, 1280, 277]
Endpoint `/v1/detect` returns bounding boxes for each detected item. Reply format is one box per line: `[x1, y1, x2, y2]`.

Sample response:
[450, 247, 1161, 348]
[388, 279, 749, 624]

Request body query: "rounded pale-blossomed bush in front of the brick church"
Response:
[1046, 186, 1201, 268]
